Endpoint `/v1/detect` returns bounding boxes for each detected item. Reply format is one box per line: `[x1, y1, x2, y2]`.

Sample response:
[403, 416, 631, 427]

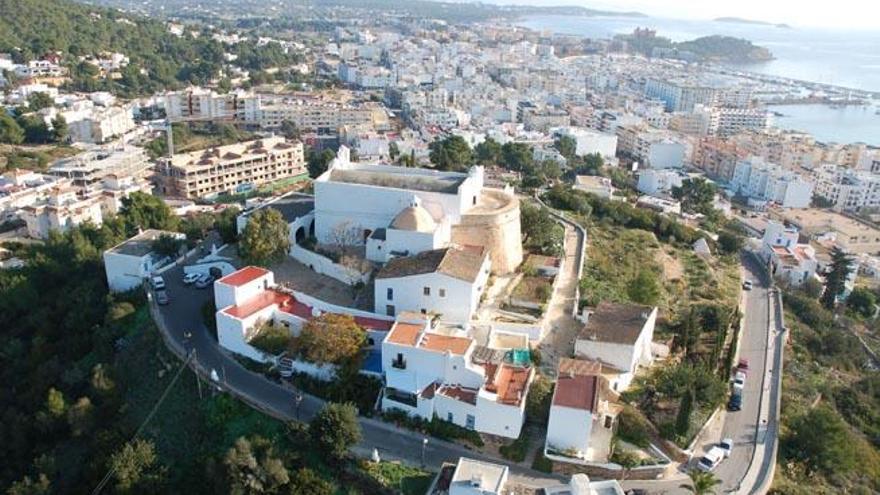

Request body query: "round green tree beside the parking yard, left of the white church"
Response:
[238, 208, 290, 266]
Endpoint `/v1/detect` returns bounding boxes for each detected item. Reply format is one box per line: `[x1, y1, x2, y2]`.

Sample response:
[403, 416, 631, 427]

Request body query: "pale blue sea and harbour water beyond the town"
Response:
[517, 15, 880, 146]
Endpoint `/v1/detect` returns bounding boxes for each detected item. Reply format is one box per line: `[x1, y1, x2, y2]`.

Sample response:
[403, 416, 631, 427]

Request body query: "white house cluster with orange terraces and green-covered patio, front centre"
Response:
[382, 313, 533, 438]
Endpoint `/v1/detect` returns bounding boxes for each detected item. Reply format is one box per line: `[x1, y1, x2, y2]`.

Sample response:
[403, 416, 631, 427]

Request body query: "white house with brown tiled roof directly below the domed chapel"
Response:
[374, 247, 491, 323]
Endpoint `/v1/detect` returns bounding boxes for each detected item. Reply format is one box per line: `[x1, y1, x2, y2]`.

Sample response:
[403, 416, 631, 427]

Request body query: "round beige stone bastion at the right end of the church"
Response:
[452, 189, 523, 275]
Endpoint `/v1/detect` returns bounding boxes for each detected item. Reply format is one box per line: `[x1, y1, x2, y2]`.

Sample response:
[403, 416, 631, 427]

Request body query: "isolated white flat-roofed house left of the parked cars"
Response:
[104, 229, 186, 292]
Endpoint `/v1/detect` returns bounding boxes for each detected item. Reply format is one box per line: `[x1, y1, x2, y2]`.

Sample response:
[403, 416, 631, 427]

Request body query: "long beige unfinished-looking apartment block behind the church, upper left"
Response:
[159, 136, 306, 198]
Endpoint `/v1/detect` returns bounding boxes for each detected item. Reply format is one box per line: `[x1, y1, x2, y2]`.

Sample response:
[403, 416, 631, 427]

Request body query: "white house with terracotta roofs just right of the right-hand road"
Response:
[761, 221, 819, 287]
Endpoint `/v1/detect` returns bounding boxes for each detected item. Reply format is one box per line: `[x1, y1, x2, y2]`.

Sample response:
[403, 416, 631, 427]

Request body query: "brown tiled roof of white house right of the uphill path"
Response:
[578, 303, 654, 345]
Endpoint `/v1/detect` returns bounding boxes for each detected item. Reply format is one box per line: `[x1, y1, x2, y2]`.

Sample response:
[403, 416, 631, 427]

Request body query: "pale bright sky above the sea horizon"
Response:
[490, 0, 880, 30]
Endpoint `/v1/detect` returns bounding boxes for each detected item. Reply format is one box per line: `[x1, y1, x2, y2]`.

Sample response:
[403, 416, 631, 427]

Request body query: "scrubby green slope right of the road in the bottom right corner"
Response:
[773, 290, 880, 495]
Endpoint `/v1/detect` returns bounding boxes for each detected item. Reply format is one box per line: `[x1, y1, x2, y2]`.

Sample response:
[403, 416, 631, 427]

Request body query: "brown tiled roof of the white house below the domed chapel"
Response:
[376, 247, 486, 282]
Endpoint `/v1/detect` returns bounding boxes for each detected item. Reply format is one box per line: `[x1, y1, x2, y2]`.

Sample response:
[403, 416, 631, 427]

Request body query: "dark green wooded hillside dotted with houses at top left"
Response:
[0, 0, 300, 95]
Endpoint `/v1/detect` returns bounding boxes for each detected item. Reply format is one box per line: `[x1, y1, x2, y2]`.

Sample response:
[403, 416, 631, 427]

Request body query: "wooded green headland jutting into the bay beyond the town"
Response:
[614, 28, 773, 64]
